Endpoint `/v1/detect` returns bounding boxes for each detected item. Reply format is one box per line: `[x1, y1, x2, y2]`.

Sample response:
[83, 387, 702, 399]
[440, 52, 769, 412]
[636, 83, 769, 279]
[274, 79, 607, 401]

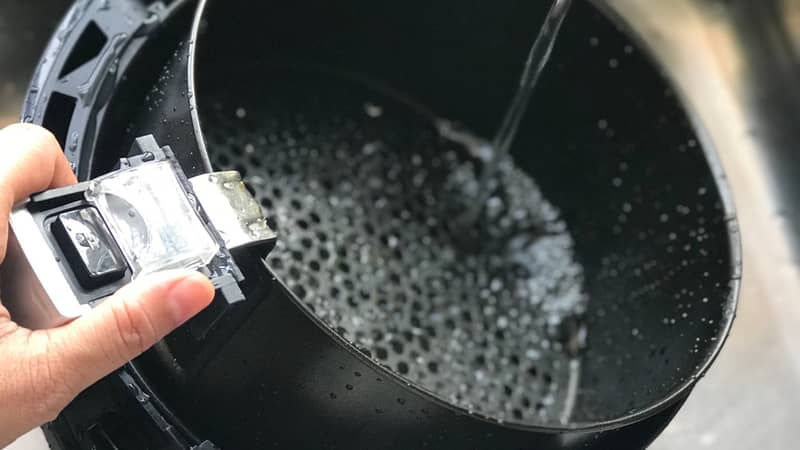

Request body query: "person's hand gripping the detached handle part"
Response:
[0, 124, 214, 448]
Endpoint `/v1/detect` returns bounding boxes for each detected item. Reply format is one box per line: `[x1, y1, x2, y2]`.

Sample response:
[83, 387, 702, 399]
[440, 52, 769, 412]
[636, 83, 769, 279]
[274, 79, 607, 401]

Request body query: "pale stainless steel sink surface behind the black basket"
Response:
[0, 0, 800, 450]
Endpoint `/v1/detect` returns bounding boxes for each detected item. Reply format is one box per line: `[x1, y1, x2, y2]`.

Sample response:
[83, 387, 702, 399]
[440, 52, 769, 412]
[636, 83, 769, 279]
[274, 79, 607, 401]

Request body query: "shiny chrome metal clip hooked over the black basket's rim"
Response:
[189, 170, 276, 249]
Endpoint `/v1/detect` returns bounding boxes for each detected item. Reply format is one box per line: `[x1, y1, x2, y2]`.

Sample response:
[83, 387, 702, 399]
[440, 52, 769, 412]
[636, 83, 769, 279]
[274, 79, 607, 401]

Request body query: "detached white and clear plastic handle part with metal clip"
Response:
[0, 135, 276, 328]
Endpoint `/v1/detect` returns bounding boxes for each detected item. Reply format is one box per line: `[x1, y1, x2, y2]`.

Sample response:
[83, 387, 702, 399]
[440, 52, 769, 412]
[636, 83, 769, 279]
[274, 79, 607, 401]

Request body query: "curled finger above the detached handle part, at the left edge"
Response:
[0, 124, 76, 261]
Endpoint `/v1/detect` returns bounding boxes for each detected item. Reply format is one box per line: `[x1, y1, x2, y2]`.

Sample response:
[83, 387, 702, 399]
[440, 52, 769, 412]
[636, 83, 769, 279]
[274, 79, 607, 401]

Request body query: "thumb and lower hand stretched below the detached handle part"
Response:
[0, 271, 214, 442]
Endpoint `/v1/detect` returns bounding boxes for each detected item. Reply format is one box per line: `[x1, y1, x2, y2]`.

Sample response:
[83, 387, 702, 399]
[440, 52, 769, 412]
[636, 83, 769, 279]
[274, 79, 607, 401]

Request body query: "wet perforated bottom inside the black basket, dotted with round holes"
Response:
[203, 71, 585, 424]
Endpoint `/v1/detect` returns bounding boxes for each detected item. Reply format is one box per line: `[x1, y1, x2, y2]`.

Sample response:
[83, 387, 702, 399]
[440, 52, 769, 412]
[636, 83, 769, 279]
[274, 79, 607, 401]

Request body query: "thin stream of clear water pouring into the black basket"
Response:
[437, 0, 572, 232]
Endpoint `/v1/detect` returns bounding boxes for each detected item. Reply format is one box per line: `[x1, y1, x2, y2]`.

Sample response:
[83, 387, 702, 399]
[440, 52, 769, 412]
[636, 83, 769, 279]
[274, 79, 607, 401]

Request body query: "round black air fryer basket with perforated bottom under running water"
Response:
[23, 0, 739, 449]
